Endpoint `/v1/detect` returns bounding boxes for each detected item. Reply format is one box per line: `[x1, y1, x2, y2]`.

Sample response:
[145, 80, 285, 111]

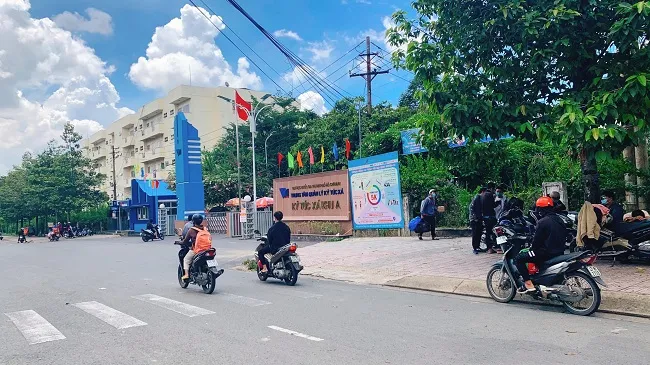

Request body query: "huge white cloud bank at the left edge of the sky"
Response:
[0, 0, 132, 174]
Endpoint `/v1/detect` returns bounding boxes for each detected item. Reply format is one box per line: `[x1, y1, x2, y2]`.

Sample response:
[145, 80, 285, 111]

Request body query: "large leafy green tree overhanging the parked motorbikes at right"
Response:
[388, 0, 650, 201]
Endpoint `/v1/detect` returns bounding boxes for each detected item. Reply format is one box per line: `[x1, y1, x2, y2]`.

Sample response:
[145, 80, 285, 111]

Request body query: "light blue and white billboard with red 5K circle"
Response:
[348, 152, 404, 229]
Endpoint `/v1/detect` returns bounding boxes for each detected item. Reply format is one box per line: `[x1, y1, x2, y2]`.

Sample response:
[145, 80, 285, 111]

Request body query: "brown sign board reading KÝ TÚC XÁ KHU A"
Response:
[273, 170, 350, 221]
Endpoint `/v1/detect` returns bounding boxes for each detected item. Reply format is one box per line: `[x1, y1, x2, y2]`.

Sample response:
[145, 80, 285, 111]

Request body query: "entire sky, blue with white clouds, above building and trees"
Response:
[0, 0, 411, 175]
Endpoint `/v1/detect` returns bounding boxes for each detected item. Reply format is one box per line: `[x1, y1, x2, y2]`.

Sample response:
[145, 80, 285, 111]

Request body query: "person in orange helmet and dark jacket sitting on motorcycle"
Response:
[515, 196, 566, 293]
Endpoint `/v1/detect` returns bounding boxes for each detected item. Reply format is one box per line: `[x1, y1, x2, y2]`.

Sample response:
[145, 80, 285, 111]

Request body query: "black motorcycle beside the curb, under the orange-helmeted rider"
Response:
[486, 226, 607, 316]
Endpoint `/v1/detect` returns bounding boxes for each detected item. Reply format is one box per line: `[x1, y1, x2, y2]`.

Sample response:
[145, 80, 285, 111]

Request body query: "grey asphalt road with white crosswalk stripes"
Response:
[0, 238, 650, 365]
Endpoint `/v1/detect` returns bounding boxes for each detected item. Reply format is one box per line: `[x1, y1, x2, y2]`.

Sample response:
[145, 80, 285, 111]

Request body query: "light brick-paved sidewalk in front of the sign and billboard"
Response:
[298, 237, 650, 316]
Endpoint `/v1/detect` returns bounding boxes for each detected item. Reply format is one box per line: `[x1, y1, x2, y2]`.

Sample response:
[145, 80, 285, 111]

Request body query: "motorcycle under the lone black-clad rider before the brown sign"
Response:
[254, 231, 303, 286]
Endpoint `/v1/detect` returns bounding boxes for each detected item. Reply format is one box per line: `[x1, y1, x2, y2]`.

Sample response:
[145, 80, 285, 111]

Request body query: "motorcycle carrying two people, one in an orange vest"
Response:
[174, 241, 223, 294]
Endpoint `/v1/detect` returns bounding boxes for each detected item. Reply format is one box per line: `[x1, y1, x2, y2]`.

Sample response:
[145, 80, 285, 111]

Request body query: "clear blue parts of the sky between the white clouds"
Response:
[31, 0, 410, 110]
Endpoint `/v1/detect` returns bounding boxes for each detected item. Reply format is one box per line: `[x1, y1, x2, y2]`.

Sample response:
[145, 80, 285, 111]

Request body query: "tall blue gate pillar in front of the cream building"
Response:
[174, 112, 205, 221]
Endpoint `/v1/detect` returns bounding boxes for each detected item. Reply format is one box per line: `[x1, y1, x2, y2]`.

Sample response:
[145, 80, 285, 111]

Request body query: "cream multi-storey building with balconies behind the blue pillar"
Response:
[81, 86, 266, 200]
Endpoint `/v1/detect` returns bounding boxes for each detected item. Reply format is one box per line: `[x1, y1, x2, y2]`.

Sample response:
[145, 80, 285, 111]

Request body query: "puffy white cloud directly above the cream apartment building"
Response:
[129, 5, 262, 91]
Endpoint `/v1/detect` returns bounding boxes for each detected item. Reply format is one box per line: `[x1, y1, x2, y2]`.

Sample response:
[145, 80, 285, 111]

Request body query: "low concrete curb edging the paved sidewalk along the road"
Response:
[384, 276, 650, 318]
